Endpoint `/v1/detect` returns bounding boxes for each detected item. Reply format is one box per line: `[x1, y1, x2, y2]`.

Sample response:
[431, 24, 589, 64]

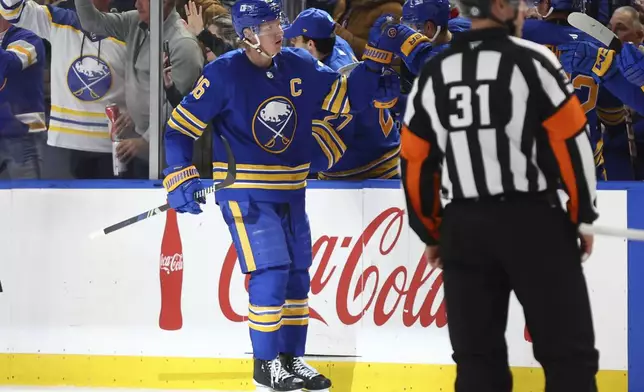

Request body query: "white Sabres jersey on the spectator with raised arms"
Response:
[0, 0, 126, 152]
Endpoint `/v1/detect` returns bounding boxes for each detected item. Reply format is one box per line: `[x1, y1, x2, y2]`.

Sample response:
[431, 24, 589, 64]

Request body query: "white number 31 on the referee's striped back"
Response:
[449, 84, 490, 128]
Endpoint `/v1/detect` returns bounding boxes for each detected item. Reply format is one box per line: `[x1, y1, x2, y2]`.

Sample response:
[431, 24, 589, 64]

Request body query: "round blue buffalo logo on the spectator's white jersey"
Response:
[67, 56, 112, 102]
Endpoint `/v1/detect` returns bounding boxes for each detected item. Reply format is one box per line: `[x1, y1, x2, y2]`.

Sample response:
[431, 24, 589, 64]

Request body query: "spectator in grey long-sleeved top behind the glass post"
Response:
[76, 0, 204, 168]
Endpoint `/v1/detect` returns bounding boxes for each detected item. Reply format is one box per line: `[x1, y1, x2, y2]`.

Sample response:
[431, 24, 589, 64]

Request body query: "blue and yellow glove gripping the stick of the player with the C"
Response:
[163, 166, 206, 214]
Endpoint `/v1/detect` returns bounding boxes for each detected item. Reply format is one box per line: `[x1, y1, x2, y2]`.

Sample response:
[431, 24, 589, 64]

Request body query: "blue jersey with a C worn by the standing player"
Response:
[165, 48, 380, 202]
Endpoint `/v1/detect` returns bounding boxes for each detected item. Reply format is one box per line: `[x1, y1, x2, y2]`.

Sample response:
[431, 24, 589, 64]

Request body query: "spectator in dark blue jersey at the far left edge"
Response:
[0, 13, 47, 179]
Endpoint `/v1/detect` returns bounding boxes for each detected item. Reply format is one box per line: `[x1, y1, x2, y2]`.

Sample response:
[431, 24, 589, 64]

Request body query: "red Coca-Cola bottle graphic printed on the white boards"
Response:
[159, 209, 183, 331]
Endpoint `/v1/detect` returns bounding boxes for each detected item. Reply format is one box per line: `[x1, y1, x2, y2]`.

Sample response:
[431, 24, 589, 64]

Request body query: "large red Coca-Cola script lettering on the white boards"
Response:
[219, 207, 447, 328]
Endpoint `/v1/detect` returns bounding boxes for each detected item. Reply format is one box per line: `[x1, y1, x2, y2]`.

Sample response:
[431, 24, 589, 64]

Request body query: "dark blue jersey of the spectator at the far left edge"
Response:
[0, 26, 47, 137]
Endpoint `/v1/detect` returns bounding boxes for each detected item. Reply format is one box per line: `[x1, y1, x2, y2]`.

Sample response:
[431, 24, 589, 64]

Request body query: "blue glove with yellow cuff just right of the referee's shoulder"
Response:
[557, 42, 618, 84]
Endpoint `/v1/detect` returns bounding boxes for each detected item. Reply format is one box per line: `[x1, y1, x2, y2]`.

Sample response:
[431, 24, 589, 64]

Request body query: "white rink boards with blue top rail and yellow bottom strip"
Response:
[0, 181, 644, 392]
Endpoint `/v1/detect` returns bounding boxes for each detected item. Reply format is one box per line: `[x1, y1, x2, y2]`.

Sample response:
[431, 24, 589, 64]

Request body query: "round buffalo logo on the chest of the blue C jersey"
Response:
[253, 97, 297, 154]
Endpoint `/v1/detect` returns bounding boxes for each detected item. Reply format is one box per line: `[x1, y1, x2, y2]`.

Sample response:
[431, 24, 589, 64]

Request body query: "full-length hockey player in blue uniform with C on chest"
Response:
[163, 0, 400, 391]
